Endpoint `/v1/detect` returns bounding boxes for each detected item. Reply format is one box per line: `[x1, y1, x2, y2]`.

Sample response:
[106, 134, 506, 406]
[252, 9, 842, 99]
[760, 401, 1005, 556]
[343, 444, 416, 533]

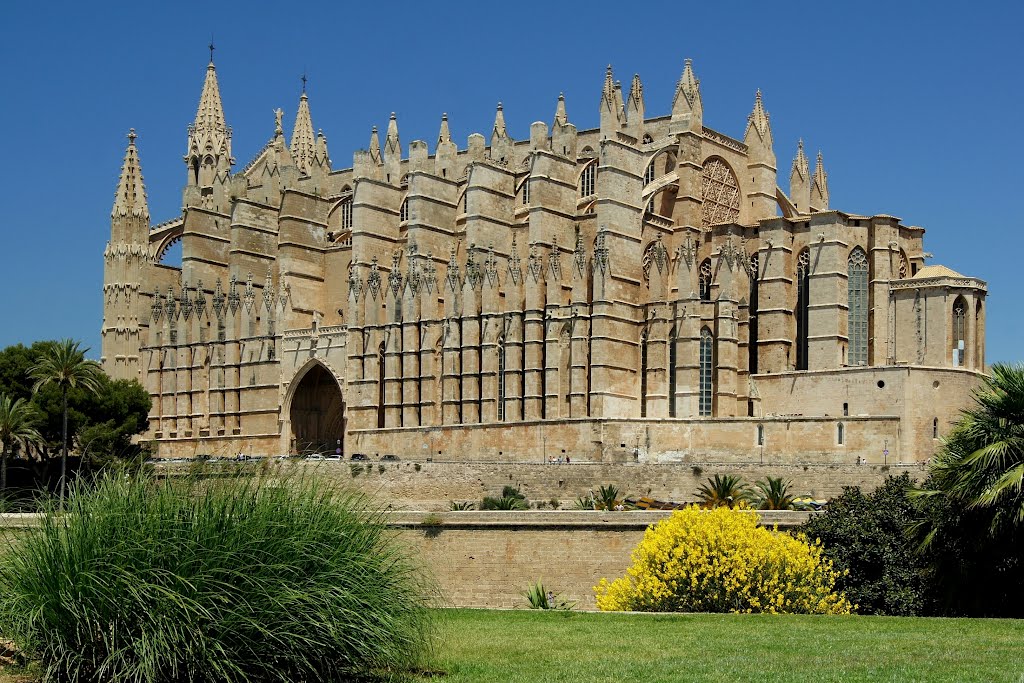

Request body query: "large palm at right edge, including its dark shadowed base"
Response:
[910, 364, 1024, 616]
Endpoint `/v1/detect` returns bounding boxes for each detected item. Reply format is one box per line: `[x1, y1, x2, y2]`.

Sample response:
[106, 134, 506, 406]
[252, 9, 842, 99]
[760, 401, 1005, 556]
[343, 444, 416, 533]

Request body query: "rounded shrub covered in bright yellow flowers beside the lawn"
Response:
[594, 506, 855, 614]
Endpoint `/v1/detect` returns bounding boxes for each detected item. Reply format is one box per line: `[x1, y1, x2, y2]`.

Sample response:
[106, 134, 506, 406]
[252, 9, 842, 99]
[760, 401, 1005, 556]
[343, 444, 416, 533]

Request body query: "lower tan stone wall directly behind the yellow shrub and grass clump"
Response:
[0, 511, 811, 609]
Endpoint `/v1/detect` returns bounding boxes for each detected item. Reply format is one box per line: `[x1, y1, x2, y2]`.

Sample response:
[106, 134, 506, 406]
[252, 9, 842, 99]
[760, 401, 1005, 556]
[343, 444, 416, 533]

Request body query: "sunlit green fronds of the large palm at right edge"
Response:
[915, 364, 1024, 545]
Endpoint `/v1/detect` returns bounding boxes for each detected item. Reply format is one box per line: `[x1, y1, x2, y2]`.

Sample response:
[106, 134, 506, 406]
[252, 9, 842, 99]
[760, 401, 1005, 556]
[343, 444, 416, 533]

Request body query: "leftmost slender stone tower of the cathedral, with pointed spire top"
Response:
[101, 128, 150, 379]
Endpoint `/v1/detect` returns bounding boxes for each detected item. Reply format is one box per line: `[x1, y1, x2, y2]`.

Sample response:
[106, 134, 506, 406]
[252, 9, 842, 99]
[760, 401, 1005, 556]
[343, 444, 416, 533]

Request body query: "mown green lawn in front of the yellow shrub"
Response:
[428, 609, 1024, 683]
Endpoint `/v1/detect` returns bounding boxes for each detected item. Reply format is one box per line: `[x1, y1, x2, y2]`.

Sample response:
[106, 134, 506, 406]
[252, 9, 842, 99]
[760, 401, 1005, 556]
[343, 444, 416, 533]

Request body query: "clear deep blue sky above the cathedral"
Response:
[0, 0, 1024, 361]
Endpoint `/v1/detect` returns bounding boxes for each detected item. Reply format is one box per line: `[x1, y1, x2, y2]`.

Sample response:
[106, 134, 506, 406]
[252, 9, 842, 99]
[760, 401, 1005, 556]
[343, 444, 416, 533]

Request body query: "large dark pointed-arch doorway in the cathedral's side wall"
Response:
[285, 361, 345, 456]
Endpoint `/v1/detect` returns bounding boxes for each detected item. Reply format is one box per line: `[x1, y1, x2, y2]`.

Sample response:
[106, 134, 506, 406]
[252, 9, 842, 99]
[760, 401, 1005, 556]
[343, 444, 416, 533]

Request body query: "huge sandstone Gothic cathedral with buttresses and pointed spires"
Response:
[102, 58, 986, 463]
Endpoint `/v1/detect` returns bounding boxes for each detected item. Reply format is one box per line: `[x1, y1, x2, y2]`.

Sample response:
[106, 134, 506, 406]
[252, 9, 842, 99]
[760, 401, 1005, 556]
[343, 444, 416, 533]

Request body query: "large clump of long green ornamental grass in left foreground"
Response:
[0, 476, 429, 683]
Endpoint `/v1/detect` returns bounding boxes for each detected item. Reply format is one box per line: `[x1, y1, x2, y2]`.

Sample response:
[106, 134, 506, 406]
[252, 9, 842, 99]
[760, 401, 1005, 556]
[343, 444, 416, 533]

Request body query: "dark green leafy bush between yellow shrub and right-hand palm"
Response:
[801, 472, 931, 616]
